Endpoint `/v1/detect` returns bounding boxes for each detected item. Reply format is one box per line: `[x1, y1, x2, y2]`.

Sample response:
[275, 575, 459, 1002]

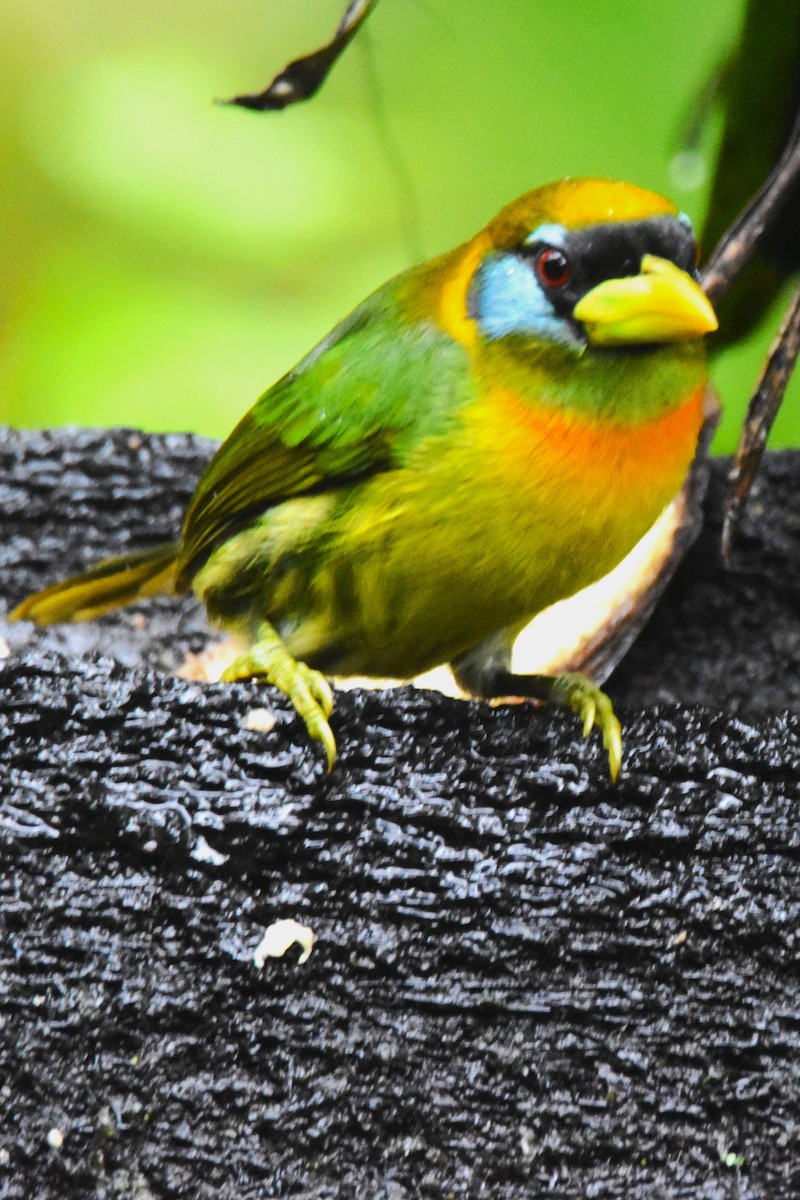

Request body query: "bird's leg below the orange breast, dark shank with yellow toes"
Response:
[452, 647, 622, 782]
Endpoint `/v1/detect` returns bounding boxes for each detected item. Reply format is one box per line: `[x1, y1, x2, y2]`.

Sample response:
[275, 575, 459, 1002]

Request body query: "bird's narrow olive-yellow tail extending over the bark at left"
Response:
[11, 542, 178, 625]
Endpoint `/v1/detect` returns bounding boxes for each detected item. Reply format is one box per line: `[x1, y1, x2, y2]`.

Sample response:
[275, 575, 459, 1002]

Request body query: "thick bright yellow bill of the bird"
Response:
[573, 254, 717, 346]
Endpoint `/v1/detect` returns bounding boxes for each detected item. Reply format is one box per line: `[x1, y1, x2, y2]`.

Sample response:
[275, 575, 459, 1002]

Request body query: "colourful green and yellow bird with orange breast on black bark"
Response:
[12, 178, 717, 780]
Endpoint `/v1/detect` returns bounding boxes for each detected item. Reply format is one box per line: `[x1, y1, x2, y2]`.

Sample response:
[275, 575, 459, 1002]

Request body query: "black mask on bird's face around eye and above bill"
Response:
[518, 216, 696, 317]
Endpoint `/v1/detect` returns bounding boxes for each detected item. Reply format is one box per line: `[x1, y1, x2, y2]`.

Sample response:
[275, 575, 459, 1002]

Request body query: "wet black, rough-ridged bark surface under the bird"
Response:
[0, 431, 800, 1200]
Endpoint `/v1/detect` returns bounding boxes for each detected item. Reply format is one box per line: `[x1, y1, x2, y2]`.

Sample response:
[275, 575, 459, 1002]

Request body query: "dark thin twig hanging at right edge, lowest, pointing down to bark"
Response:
[722, 278, 800, 562]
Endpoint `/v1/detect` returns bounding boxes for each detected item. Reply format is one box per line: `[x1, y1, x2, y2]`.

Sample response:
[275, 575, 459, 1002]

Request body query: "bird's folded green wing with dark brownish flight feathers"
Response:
[178, 276, 469, 588]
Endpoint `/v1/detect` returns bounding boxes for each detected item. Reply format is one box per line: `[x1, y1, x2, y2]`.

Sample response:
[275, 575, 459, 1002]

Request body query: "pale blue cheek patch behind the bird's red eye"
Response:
[469, 253, 583, 349]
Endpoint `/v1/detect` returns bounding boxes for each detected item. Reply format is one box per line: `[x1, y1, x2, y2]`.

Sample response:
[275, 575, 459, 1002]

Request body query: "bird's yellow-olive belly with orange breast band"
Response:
[277, 379, 703, 678]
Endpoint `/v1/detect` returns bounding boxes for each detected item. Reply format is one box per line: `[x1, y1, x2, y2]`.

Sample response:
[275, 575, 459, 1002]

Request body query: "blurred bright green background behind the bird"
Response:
[0, 0, 800, 450]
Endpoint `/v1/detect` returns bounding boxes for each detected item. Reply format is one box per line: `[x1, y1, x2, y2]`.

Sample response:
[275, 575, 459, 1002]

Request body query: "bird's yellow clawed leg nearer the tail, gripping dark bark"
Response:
[222, 620, 336, 770]
